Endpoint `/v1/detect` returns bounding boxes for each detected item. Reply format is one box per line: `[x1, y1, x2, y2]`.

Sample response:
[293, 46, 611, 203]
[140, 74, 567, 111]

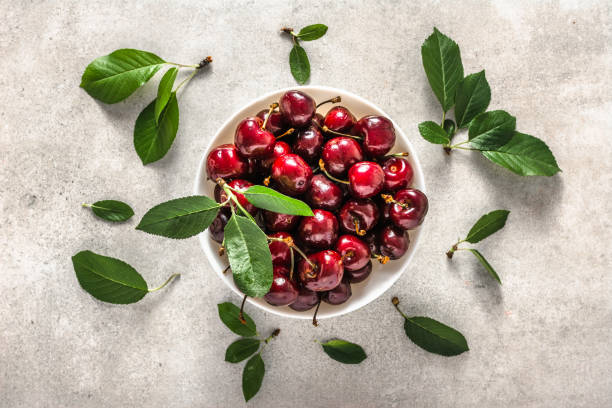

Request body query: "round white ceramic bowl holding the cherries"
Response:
[194, 86, 425, 319]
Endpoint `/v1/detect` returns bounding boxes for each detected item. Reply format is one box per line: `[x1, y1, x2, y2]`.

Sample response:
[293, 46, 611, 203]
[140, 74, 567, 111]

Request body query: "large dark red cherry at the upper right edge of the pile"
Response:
[352, 115, 395, 158]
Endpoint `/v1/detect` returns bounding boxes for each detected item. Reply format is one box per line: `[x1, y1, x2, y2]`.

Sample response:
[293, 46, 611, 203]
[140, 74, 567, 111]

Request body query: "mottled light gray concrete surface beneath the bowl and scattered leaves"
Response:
[0, 0, 612, 408]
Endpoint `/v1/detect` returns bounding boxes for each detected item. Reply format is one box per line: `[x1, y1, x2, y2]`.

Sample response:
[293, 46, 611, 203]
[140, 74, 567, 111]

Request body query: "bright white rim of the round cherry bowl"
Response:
[193, 85, 427, 320]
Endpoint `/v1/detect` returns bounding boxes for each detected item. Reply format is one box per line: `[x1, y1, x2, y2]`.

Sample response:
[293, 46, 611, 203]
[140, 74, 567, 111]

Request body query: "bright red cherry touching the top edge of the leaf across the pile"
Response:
[272, 154, 312, 196]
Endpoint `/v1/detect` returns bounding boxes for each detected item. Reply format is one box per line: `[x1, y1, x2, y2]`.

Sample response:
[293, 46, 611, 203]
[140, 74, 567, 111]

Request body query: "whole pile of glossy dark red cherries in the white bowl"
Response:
[206, 91, 428, 311]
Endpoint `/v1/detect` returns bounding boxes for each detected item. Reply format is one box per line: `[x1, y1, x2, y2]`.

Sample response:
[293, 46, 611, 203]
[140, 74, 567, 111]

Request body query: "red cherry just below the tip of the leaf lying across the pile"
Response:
[297, 209, 338, 249]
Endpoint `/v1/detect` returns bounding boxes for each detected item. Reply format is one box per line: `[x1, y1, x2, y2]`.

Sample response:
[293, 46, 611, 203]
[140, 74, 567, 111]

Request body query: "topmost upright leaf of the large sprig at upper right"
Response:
[421, 27, 463, 112]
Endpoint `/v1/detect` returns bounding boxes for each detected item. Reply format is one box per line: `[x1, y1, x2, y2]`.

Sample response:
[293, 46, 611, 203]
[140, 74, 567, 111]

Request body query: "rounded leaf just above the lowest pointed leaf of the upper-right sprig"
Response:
[468, 110, 516, 150]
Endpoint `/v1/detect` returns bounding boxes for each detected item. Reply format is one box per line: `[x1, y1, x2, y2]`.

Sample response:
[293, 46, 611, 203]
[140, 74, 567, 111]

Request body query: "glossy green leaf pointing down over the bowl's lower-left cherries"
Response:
[224, 214, 272, 297]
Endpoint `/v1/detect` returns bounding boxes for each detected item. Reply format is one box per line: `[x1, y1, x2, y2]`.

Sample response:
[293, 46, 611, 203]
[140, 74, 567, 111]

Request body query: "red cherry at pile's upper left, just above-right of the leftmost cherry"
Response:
[234, 116, 276, 159]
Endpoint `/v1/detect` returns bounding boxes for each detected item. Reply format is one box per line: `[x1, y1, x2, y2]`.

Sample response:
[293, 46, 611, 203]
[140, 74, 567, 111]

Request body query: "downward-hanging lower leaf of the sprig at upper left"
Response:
[134, 92, 179, 164]
